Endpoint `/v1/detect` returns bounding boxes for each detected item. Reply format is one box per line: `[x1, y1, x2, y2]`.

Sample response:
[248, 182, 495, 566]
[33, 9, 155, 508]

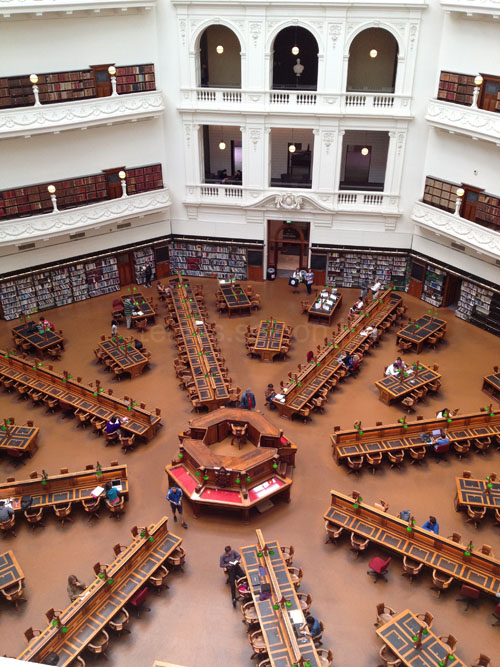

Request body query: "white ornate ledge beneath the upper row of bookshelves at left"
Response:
[0, 90, 165, 139]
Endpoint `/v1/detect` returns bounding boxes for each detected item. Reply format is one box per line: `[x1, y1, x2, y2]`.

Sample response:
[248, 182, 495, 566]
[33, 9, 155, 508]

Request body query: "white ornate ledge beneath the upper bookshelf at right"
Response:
[425, 99, 500, 145]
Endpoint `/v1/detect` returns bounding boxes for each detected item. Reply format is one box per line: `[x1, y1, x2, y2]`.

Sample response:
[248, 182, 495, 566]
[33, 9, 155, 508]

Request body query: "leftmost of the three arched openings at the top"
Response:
[199, 25, 241, 88]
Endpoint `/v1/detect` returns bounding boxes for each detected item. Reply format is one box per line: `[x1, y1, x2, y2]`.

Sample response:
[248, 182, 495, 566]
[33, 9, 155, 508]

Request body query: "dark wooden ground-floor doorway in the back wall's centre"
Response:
[267, 220, 310, 278]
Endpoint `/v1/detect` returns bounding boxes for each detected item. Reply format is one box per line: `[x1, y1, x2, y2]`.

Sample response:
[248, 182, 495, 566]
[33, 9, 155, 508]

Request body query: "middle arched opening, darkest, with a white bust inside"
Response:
[272, 26, 318, 90]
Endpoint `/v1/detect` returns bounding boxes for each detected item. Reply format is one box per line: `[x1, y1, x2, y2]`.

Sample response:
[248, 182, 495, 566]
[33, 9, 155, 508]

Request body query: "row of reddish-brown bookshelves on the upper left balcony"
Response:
[0, 63, 156, 109]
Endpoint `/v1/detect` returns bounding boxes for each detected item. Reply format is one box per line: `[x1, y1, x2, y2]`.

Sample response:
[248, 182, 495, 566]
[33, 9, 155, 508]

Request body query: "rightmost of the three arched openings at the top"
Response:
[347, 28, 398, 93]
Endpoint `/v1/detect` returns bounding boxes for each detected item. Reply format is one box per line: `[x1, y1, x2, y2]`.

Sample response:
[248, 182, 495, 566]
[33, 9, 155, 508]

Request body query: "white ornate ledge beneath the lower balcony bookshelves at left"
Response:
[0, 188, 172, 245]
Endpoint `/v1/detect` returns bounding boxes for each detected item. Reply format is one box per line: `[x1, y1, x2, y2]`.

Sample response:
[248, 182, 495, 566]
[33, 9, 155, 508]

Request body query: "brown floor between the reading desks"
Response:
[0, 279, 500, 667]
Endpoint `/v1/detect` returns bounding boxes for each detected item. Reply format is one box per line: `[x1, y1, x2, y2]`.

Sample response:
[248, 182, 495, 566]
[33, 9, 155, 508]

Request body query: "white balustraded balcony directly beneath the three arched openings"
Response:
[179, 88, 411, 118]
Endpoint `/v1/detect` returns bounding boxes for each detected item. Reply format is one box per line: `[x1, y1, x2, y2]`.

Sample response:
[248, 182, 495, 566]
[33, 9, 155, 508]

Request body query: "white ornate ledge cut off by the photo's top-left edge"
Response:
[0, 0, 156, 19]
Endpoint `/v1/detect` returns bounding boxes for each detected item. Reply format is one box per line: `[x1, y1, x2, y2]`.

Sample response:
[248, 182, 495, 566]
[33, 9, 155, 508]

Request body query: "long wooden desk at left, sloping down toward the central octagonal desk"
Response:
[0, 350, 160, 440]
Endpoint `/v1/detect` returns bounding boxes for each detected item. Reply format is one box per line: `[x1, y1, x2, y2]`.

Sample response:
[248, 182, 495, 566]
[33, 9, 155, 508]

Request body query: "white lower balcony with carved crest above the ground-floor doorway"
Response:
[186, 184, 399, 216]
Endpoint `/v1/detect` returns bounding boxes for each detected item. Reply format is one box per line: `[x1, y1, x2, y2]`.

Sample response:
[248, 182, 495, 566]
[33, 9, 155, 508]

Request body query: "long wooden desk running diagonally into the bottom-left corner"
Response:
[17, 516, 182, 667]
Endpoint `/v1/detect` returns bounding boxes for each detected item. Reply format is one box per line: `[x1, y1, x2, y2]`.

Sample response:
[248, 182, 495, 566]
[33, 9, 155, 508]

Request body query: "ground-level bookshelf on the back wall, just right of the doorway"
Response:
[327, 251, 408, 290]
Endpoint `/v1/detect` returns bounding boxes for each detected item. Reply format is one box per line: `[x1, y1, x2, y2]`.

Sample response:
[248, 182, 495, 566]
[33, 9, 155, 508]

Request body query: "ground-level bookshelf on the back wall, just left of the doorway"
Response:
[170, 241, 247, 280]
